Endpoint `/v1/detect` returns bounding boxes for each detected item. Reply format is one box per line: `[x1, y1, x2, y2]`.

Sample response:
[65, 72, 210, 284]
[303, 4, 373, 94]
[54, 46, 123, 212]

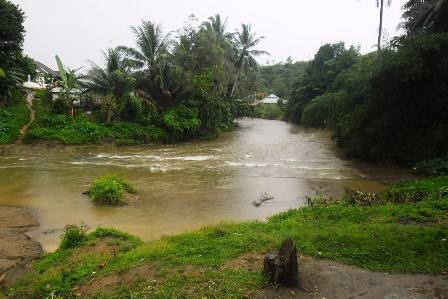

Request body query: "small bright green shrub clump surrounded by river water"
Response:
[85, 174, 137, 206]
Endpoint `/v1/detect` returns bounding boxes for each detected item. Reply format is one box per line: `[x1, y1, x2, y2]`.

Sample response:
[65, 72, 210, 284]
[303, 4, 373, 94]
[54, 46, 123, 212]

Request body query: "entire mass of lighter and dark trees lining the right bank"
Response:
[287, 0, 448, 165]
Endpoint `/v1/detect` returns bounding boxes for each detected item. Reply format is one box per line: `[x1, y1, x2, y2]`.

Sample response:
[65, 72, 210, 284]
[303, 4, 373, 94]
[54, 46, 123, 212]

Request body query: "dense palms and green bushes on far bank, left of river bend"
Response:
[0, 8, 274, 144]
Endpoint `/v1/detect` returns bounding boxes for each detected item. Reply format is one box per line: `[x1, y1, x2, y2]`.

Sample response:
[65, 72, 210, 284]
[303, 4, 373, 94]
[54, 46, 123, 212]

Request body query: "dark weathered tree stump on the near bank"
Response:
[264, 239, 299, 287]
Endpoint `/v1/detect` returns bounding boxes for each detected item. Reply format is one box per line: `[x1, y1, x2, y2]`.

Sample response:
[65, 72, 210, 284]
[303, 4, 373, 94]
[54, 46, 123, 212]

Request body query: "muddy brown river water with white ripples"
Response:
[0, 119, 408, 251]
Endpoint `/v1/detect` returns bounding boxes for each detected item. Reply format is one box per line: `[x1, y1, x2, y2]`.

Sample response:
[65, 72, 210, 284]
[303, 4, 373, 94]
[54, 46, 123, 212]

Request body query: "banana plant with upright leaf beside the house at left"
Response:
[55, 55, 83, 118]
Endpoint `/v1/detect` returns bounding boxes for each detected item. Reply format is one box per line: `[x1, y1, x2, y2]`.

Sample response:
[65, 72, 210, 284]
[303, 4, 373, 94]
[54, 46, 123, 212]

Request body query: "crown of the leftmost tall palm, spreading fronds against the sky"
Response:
[119, 20, 172, 70]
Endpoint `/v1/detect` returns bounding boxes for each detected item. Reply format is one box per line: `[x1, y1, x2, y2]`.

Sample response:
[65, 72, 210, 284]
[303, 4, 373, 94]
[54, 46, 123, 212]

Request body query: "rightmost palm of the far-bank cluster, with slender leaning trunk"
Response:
[228, 24, 269, 98]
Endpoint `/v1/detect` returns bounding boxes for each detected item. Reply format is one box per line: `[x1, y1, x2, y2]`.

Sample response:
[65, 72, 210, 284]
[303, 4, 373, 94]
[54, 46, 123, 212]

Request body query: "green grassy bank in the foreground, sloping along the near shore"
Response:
[5, 176, 448, 298]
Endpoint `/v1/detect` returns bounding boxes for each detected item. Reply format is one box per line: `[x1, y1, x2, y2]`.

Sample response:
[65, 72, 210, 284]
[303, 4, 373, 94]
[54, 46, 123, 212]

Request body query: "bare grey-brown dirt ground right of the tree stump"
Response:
[253, 256, 448, 299]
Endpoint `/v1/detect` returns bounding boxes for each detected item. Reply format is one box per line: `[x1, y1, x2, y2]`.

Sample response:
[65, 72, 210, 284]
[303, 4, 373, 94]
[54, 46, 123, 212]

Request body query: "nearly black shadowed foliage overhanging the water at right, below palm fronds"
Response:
[335, 34, 448, 164]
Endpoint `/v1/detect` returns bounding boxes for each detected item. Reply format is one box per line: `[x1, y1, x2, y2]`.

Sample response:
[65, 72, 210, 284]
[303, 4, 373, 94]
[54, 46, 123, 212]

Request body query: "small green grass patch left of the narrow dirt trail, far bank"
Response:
[0, 103, 30, 144]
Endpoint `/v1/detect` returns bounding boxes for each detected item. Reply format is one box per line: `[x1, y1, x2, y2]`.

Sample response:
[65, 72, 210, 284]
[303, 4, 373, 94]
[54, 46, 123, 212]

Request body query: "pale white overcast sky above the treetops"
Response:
[10, 0, 405, 71]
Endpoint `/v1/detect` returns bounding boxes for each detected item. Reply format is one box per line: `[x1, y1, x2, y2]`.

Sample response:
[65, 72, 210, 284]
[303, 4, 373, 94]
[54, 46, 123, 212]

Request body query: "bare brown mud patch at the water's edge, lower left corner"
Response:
[0, 206, 42, 289]
